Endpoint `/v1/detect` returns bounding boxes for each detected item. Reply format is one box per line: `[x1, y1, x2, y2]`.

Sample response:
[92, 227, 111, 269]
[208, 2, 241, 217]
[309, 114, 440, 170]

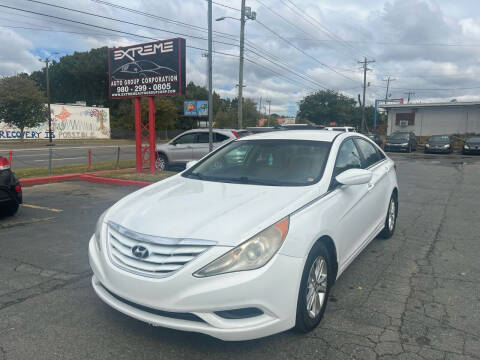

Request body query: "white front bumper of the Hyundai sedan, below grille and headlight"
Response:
[89, 237, 304, 341]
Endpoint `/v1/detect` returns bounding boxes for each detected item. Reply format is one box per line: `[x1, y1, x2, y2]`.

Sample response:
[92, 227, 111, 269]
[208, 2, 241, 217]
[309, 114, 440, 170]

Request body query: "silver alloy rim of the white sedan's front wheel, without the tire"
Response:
[306, 256, 328, 319]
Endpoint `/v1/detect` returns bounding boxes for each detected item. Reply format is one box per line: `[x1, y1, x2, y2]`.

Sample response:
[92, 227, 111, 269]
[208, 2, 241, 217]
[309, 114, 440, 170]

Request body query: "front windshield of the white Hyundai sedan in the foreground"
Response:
[183, 140, 330, 186]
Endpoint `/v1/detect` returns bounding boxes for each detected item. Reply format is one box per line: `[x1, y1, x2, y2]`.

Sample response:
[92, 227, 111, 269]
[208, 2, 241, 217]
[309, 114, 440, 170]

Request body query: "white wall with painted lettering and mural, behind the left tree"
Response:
[0, 104, 110, 140]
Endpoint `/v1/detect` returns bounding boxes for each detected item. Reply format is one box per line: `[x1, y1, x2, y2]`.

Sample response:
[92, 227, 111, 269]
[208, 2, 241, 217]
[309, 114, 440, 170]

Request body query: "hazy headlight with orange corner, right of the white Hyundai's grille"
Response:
[193, 216, 290, 277]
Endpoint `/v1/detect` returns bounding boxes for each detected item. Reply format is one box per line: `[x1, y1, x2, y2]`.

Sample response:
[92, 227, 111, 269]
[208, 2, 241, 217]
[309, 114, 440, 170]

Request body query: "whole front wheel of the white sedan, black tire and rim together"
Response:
[295, 242, 334, 333]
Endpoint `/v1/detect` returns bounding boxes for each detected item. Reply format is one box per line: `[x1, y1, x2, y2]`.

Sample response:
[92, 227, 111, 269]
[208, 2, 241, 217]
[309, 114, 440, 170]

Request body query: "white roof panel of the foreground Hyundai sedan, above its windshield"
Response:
[239, 130, 348, 142]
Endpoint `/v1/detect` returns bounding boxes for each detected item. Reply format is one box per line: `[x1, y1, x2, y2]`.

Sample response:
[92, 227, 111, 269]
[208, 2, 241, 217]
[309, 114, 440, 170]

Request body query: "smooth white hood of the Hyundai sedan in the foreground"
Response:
[106, 175, 320, 246]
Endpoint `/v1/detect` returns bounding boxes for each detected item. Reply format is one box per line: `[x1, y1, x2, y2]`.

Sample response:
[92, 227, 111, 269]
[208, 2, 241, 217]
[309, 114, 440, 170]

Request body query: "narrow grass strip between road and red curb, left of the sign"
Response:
[13, 160, 135, 179]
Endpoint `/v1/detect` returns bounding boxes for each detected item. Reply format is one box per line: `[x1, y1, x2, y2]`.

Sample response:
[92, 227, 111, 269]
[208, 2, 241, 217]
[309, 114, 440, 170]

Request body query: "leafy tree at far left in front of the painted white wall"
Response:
[0, 74, 49, 139]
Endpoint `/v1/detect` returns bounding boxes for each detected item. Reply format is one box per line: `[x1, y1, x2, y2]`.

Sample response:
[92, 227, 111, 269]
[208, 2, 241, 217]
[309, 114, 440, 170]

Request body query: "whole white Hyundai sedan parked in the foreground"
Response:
[89, 130, 398, 340]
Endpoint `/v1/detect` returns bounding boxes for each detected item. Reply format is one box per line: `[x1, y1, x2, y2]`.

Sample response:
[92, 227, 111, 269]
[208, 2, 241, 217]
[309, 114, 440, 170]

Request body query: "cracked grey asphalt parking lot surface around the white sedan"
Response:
[0, 153, 480, 360]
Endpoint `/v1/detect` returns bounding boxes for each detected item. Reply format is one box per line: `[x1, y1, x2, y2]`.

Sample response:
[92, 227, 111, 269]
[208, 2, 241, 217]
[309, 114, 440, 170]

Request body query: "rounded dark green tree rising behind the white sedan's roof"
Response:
[297, 90, 356, 126]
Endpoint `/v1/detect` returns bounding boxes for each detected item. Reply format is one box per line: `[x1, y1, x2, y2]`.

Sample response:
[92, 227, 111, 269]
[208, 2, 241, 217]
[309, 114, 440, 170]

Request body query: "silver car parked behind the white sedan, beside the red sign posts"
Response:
[155, 129, 244, 171]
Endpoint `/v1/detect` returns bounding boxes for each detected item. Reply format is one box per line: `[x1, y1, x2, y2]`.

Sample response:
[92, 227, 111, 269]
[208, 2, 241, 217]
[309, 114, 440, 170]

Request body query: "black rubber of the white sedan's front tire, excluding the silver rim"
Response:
[295, 242, 334, 333]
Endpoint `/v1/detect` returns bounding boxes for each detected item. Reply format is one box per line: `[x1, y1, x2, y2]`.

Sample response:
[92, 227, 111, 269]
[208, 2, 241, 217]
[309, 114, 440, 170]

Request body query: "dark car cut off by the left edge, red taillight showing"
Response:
[0, 156, 22, 216]
